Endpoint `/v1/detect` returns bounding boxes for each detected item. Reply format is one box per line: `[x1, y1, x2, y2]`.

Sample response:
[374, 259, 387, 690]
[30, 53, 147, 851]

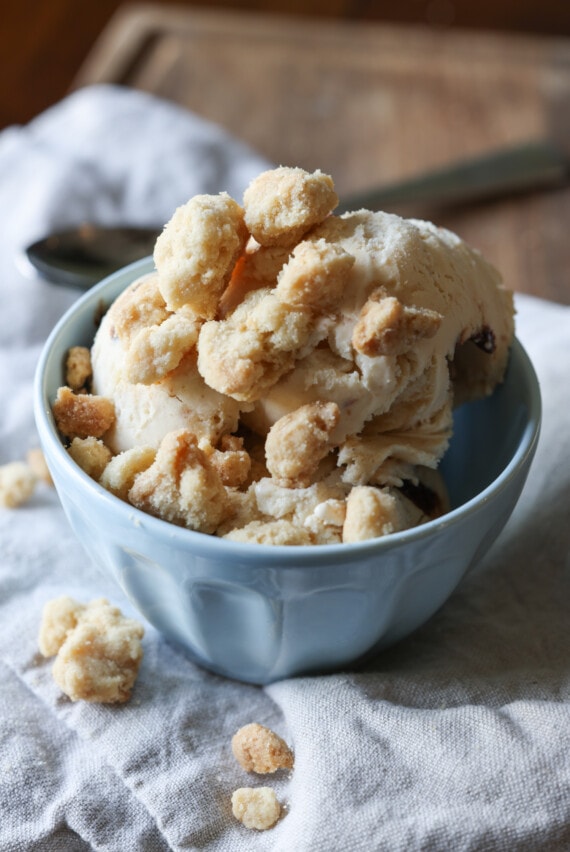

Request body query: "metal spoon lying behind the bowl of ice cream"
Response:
[25, 140, 570, 290]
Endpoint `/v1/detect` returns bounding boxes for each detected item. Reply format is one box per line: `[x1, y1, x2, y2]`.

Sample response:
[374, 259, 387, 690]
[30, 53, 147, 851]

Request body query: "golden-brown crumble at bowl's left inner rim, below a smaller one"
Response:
[52, 386, 115, 439]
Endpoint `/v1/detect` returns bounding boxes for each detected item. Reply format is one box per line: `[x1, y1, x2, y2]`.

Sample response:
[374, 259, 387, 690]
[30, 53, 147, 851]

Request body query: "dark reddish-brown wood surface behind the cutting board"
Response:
[0, 0, 570, 128]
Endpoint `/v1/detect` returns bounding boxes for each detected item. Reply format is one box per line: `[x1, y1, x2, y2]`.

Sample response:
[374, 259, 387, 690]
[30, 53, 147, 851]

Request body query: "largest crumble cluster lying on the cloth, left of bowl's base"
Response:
[39, 596, 144, 704]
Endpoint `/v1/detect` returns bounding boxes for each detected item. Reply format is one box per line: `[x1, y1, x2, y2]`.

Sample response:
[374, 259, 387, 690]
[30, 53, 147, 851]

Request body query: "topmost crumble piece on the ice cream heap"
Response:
[243, 166, 338, 247]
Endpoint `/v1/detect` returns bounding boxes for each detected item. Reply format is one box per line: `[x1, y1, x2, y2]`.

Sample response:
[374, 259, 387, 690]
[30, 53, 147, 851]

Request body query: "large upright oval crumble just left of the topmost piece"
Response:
[154, 192, 249, 319]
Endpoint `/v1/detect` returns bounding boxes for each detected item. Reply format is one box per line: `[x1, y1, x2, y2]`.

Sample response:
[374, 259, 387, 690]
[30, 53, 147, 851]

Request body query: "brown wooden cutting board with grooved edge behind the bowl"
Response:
[74, 4, 570, 304]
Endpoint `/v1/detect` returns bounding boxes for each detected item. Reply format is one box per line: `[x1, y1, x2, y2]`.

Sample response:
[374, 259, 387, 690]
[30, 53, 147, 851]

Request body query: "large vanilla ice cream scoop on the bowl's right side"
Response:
[237, 211, 514, 483]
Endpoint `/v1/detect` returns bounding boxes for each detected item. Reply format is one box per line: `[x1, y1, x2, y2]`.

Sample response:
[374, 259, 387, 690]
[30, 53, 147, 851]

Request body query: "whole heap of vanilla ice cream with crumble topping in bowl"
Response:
[54, 163, 514, 544]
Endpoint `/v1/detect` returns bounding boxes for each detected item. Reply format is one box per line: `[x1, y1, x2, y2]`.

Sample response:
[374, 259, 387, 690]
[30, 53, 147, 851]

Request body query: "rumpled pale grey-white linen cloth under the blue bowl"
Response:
[0, 87, 570, 852]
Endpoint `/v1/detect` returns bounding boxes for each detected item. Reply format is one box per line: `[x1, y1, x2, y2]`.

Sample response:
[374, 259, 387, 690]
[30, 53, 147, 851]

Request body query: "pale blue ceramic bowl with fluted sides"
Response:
[35, 259, 541, 684]
